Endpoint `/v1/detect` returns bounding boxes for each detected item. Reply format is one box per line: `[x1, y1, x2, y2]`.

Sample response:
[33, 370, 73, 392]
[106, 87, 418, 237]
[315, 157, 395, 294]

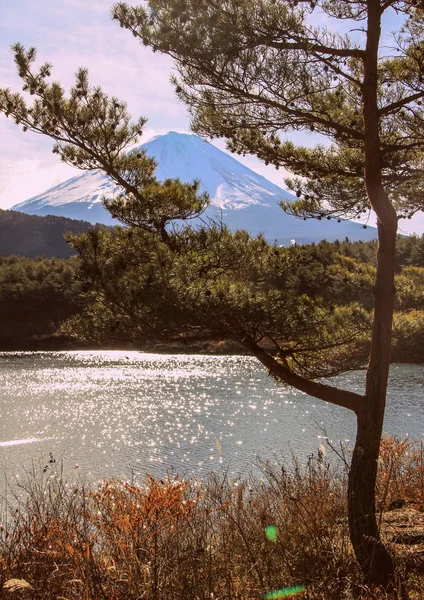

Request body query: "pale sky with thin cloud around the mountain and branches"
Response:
[0, 0, 424, 234]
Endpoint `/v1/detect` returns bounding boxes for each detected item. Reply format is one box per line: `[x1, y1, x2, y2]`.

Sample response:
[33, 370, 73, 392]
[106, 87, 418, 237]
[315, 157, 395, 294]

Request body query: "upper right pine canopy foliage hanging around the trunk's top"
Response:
[112, 0, 424, 218]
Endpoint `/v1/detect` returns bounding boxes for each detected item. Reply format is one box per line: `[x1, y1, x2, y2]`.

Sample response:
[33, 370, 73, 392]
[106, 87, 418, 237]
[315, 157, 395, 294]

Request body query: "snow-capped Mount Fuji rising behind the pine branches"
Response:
[12, 131, 377, 245]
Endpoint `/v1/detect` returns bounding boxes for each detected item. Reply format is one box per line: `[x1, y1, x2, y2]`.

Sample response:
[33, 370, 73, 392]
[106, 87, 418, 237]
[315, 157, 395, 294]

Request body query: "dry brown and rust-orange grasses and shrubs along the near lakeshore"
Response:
[0, 438, 424, 600]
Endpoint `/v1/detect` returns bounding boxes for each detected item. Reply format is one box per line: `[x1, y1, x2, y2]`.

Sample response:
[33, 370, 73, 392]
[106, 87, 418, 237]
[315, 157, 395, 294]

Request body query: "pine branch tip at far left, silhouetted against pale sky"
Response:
[0, 44, 148, 171]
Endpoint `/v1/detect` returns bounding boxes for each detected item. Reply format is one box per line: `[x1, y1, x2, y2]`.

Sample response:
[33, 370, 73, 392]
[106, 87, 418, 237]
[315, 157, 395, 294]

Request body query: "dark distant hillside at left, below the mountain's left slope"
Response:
[0, 210, 92, 258]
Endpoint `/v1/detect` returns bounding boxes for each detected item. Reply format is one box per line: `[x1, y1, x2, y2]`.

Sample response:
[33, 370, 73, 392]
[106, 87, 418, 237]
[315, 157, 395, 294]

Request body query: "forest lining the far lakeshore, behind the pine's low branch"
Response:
[0, 232, 424, 362]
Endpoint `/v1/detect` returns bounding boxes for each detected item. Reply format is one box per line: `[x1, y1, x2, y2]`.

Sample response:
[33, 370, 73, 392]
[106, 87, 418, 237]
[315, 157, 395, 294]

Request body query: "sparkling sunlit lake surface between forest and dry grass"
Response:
[0, 351, 424, 480]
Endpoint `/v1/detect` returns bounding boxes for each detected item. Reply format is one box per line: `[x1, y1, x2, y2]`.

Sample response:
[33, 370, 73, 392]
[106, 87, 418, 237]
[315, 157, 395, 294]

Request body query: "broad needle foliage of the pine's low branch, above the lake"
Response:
[64, 225, 370, 375]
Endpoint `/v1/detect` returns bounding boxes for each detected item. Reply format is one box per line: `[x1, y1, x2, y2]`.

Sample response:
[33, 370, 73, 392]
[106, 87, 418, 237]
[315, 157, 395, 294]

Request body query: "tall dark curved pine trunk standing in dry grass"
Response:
[348, 0, 401, 592]
